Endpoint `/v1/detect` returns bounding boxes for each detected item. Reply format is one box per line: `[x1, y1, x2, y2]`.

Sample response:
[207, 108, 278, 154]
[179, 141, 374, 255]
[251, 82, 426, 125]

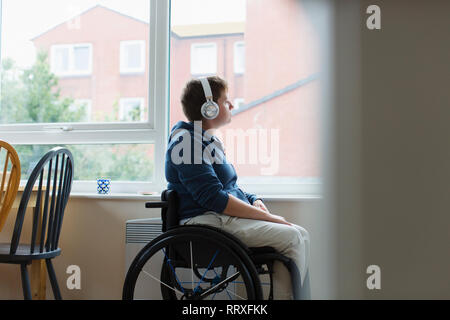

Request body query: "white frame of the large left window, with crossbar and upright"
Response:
[0, 0, 170, 193]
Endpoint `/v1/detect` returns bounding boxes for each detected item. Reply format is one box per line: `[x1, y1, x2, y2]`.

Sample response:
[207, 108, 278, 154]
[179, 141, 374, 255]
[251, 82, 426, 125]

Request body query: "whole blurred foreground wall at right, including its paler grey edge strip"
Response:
[326, 0, 450, 299]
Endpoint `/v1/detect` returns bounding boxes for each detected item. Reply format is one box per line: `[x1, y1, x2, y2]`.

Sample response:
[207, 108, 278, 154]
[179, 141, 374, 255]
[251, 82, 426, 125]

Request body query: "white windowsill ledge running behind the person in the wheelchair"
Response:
[70, 192, 322, 202]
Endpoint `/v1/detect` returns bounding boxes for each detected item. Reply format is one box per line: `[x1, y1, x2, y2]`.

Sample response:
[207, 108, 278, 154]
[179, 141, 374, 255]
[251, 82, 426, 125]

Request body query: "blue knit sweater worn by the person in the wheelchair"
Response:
[165, 121, 258, 220]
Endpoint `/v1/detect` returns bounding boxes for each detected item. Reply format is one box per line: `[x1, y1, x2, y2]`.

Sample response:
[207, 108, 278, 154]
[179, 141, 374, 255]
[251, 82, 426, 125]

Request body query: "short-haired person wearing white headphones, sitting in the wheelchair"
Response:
[165, 76, 310, 299]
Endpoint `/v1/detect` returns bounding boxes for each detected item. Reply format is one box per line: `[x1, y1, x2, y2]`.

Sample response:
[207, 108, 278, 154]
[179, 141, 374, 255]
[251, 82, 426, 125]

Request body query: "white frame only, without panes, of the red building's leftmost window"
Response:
[50, 42, 93, 77]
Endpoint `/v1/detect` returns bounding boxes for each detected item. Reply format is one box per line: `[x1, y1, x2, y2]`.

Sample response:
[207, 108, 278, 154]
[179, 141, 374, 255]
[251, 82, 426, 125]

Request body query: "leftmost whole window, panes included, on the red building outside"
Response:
[51, 43, 92, 76]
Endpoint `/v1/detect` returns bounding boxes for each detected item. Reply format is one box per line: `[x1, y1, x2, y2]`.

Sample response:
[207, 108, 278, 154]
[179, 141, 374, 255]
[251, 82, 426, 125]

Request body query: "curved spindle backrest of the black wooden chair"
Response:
[10, 147, 73, 254]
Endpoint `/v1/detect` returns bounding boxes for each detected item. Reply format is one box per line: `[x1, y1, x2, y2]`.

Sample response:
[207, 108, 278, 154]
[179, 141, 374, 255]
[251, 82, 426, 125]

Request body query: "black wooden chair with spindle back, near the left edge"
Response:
[0, 147, 73, 300]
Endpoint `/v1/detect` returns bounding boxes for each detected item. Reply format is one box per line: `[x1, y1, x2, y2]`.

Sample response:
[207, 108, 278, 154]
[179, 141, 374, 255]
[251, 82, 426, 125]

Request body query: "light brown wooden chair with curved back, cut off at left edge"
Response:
[0, 140, 20, 231]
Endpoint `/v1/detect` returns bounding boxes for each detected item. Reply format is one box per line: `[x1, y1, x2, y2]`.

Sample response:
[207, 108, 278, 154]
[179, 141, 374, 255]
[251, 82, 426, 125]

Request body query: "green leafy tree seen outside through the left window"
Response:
[0, 52, 153, 181]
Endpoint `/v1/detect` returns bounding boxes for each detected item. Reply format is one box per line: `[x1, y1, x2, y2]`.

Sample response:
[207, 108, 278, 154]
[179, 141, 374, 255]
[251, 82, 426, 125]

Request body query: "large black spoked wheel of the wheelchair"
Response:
[123, 227, 262, 300]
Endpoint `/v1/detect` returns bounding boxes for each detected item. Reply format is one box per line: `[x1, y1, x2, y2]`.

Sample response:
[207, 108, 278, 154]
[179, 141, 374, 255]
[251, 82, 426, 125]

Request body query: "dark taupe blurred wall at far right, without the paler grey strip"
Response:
[361, 0, 450, 299]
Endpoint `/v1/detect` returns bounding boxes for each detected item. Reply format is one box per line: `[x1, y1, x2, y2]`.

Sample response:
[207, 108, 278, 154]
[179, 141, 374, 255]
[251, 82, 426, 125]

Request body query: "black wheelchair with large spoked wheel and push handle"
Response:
[122, 190, 301, 300]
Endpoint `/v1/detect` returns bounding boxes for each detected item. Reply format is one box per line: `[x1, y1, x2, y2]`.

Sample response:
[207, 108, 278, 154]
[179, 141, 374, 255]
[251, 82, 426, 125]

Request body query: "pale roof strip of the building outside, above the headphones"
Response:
[172, 21, 245, 38]
